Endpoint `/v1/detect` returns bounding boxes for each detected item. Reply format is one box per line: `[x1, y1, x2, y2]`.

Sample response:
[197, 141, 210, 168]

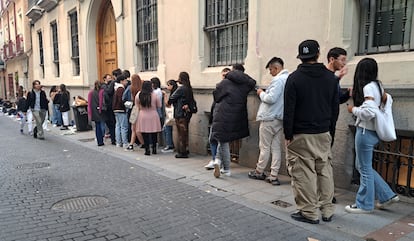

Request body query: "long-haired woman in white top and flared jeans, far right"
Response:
[345, 58, 399, 213]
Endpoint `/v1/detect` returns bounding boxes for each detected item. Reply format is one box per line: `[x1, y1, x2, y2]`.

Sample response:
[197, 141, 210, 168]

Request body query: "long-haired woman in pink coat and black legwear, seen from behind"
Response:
[135, 81, 161, 155]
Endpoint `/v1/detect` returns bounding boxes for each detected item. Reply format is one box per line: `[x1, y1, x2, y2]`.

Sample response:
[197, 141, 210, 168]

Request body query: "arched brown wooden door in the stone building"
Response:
[96, 0, 118, 78]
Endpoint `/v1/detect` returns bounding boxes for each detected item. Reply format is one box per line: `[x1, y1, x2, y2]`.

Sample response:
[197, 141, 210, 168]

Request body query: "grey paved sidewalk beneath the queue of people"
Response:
[10, 116, 414, 241]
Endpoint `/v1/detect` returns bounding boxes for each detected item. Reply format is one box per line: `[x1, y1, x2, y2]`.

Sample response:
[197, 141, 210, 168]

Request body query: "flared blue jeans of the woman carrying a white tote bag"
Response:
[355, 127, 395, 211]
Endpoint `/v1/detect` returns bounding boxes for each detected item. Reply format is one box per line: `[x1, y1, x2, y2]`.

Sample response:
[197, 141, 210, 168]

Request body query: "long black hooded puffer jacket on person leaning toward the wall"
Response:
[211, 70, 256, 142]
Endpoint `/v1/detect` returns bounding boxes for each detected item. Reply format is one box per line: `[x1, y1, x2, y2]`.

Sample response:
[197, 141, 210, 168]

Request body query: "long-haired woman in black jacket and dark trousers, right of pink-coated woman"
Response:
[168, 72, 194, 158]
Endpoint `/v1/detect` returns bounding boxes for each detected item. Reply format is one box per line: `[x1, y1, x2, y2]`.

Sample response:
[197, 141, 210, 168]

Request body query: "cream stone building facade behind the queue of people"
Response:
[2, 0, 414, 192]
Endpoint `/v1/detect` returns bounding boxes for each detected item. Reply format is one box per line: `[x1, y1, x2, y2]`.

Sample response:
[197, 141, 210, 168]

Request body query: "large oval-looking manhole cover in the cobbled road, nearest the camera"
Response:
[52, 196, 109, 212]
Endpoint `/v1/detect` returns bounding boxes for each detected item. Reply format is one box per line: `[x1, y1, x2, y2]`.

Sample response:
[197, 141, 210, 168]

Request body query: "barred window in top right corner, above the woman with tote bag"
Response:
[359, 0, 414, 54]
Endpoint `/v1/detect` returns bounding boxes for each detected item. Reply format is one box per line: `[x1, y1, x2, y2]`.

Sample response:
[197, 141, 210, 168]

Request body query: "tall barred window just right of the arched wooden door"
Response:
[137, 0, 158, 71]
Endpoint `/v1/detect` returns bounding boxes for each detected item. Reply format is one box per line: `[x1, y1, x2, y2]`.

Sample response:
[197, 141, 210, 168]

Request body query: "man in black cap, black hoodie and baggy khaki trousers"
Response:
[283, 40, 339, 224]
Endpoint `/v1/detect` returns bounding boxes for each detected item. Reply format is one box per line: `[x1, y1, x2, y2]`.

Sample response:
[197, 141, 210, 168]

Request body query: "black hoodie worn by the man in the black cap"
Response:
[283, 63, 339, 140]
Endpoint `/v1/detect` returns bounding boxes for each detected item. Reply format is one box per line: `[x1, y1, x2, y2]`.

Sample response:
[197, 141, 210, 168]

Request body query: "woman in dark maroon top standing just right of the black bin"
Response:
[88, 80, 106, 146]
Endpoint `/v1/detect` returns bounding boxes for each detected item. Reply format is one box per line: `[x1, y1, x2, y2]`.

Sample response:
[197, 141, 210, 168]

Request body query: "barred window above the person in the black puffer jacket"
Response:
[204, 0, 248, 66]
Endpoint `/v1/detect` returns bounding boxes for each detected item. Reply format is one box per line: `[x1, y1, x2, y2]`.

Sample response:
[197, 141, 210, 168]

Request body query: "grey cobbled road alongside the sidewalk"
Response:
[0, 116, 360, 241]
